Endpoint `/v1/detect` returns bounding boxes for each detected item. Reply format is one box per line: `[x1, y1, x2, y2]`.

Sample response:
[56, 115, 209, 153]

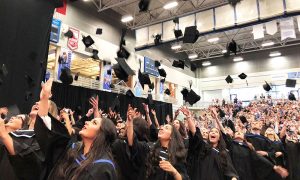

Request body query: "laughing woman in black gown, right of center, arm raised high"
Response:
[181, 108, 238, 180]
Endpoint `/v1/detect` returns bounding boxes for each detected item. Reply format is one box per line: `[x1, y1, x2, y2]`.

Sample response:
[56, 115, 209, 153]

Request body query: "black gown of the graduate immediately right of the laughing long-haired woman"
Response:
[224, 135, 275, 180]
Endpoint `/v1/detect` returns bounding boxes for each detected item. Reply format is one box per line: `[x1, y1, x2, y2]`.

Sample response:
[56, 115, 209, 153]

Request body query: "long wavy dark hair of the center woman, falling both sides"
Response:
[146, 125, 186, 178]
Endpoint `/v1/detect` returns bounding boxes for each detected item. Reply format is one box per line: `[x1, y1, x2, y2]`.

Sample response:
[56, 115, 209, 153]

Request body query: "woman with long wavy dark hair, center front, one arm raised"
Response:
[126, 106, 188, 180]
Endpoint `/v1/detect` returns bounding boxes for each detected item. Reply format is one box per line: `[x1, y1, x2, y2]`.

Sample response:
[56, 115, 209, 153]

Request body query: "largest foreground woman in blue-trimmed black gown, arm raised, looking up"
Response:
[35, 79, 117, 180]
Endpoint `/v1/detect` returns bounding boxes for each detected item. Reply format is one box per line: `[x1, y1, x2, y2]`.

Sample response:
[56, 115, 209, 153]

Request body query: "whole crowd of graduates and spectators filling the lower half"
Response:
[0, 79, 300, 180]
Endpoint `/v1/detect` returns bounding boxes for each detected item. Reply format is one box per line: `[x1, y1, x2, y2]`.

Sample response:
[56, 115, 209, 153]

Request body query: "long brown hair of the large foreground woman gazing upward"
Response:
[54, 118, 117, 180]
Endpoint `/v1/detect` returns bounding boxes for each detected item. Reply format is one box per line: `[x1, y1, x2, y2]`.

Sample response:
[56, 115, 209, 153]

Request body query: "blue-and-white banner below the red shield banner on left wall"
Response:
[57, 48, 73, 79]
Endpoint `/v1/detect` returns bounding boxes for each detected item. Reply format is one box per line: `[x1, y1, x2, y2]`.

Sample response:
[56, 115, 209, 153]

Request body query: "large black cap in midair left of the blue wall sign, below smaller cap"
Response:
[112, 58, 135, 81]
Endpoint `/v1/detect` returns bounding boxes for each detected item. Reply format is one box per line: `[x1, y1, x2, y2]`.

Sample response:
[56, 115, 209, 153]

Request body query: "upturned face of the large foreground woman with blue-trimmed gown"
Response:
[79, 118, 102, 140]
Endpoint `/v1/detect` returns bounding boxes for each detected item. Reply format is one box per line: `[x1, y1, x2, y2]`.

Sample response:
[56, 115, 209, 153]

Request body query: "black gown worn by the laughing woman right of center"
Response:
[187, 128, 238, 180]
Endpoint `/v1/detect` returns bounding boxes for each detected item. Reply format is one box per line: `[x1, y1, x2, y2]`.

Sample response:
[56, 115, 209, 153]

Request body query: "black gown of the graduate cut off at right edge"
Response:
[283, 137, 300, 180]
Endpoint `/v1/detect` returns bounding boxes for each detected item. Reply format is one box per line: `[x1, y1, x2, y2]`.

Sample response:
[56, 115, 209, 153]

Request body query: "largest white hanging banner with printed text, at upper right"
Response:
[280, 18, 296, 41]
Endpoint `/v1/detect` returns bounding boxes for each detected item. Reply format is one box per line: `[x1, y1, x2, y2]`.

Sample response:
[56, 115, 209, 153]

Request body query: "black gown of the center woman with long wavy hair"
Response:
[130, 138, 189, 180]
